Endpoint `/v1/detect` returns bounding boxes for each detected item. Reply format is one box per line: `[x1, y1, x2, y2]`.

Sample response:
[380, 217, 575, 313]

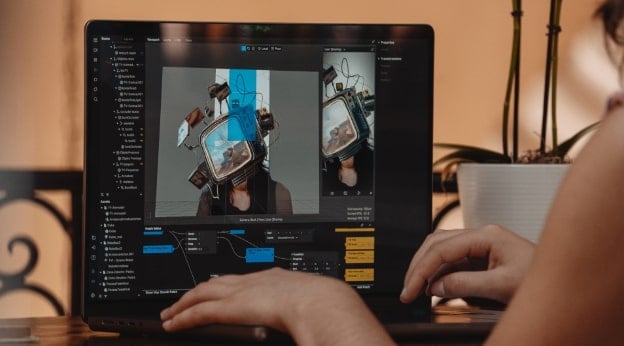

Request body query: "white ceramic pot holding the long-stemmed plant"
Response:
[457, 163, 569, 242]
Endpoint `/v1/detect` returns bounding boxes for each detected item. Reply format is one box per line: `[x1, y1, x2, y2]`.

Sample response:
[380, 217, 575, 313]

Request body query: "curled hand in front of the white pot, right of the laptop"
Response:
[400, 225, 535, 303]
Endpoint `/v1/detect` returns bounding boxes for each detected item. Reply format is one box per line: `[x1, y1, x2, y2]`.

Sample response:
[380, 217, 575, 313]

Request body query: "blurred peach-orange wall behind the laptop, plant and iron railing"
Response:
[0, 0, 619, 317]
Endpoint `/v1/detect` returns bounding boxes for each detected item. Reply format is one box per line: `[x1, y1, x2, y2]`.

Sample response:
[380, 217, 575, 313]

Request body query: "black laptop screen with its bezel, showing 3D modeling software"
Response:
[83, 21, 433, 324]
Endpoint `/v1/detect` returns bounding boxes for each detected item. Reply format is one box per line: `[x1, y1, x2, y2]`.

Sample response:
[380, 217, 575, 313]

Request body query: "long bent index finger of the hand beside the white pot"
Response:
[400, 230, 491, 302]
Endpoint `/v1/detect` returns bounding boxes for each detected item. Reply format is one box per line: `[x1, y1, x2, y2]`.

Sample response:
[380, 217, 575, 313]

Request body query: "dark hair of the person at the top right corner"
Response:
[594, 0, 624, 81]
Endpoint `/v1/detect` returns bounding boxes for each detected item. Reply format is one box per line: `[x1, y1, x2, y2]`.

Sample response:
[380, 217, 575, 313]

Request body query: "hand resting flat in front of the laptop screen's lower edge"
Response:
[161, 268, 392, 345]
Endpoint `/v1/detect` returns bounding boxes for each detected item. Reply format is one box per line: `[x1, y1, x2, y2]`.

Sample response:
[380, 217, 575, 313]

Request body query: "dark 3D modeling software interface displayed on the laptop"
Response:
[86, 23, 434, 299]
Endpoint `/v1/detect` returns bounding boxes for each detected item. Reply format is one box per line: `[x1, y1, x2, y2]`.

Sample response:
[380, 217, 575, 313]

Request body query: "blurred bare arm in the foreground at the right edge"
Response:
[489, 110, 624, 345]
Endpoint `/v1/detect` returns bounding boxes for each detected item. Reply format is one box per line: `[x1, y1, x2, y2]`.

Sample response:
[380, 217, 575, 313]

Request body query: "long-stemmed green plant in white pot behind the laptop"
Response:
[433, 0, 598, 241]
